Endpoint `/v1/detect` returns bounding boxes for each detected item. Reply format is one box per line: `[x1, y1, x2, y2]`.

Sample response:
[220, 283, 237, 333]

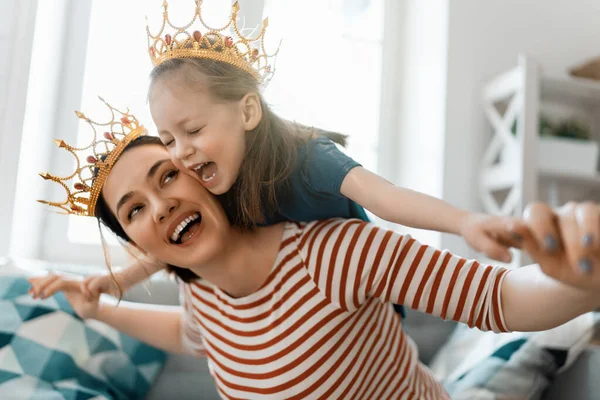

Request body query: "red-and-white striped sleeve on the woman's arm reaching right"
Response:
[300, 220, 507, 332]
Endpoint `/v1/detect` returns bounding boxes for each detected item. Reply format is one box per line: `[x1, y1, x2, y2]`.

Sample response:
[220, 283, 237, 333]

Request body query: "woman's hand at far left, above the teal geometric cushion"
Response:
[29, 274, 100, 319]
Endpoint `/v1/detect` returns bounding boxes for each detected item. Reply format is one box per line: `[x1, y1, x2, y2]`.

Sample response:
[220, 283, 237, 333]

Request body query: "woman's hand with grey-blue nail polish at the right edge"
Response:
[514, 203, 600, 291]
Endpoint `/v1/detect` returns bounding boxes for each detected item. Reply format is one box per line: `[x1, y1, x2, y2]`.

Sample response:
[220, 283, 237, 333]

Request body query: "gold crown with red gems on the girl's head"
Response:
[146, 0, 279, 84]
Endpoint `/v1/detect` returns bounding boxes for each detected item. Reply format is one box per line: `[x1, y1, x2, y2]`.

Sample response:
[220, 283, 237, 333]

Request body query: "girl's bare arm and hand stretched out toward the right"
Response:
[340, 167, 518, 262]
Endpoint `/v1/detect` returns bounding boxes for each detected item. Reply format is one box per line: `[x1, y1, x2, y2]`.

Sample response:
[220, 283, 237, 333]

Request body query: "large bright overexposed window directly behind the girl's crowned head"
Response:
[34, 0, 383, 268]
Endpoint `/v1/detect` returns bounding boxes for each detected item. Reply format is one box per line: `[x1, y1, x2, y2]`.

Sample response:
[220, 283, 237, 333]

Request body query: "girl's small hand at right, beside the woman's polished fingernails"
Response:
[459, 214, 522, 263]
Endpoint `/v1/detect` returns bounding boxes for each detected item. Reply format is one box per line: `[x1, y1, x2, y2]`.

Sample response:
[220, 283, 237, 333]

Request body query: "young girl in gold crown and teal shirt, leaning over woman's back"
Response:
[88, 3, 524, 300]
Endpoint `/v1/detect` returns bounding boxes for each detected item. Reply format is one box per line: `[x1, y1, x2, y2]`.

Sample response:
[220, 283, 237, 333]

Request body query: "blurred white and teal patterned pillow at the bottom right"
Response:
[432, 313, 596, 400]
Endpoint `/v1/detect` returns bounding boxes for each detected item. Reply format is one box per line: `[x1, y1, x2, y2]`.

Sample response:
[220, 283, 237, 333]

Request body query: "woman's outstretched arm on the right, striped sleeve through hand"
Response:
[300, 202, 600, 332]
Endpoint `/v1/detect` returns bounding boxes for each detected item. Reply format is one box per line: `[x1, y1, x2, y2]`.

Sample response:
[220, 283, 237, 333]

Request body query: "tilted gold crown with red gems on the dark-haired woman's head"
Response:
[38, 97, 147, 217]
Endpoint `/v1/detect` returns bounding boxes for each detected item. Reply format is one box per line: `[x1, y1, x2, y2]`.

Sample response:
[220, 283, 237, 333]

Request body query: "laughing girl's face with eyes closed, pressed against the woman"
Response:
[150, 79, 260, 194]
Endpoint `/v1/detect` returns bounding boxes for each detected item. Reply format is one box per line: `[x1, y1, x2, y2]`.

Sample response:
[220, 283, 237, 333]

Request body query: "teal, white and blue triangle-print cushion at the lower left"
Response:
[0, 276, 166, 400]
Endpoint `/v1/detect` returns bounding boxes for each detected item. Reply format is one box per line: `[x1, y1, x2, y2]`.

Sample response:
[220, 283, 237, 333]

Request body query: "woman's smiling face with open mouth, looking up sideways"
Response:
[102, 145, 230, 268]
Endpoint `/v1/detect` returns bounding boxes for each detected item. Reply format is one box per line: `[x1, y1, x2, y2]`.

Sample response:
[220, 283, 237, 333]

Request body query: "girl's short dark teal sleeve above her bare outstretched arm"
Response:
[304, 137, 360, 195]
